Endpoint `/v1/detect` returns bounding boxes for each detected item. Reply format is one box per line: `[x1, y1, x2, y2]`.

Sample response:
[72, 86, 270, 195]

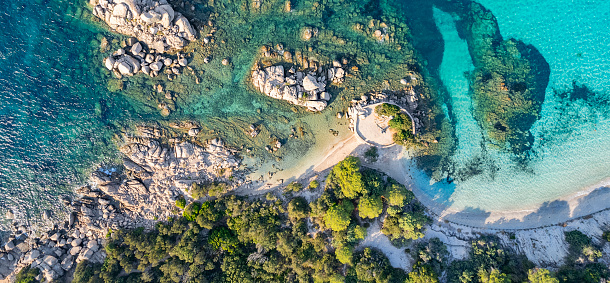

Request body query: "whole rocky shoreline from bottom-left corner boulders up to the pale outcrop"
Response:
[0, 126, 245, 282]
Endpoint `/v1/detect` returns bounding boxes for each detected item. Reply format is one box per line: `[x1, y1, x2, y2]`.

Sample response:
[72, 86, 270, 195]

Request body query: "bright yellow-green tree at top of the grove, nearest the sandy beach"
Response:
[332, 156, 365, 199]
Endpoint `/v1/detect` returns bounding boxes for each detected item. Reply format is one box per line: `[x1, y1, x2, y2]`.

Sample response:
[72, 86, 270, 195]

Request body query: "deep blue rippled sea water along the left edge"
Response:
[0, 1, 148, 226]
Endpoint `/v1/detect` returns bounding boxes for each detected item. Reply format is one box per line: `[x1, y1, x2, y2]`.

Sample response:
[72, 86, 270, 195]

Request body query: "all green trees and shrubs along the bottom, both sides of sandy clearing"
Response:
[67, 157, 609, 283]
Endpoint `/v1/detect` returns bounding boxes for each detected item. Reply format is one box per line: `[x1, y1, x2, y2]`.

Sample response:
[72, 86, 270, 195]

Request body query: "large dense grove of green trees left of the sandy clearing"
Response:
[75, 157, 432, 283]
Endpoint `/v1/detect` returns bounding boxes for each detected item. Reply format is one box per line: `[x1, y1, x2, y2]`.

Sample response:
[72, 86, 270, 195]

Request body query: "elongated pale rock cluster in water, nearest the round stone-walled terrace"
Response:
[252, 62, 345, 111]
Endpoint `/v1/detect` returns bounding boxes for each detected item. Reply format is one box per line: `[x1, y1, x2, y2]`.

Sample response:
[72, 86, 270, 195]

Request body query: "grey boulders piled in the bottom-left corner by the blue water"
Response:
[0, 197, 107, 282]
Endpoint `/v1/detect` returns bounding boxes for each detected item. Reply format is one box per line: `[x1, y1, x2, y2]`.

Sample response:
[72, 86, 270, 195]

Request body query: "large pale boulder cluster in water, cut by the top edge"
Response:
[92, 0, 196, 53]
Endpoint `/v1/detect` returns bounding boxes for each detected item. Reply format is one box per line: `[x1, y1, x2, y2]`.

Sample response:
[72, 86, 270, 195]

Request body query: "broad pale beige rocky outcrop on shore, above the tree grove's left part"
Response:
[92, 127, 241, 220]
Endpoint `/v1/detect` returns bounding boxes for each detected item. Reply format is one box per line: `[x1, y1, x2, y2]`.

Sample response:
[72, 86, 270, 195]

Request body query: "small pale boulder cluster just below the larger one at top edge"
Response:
[104, 38, 192, 79]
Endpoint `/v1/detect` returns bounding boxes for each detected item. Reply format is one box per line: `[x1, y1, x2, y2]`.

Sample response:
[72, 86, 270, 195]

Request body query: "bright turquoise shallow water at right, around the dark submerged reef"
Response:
[406, 0, 610, 216]
